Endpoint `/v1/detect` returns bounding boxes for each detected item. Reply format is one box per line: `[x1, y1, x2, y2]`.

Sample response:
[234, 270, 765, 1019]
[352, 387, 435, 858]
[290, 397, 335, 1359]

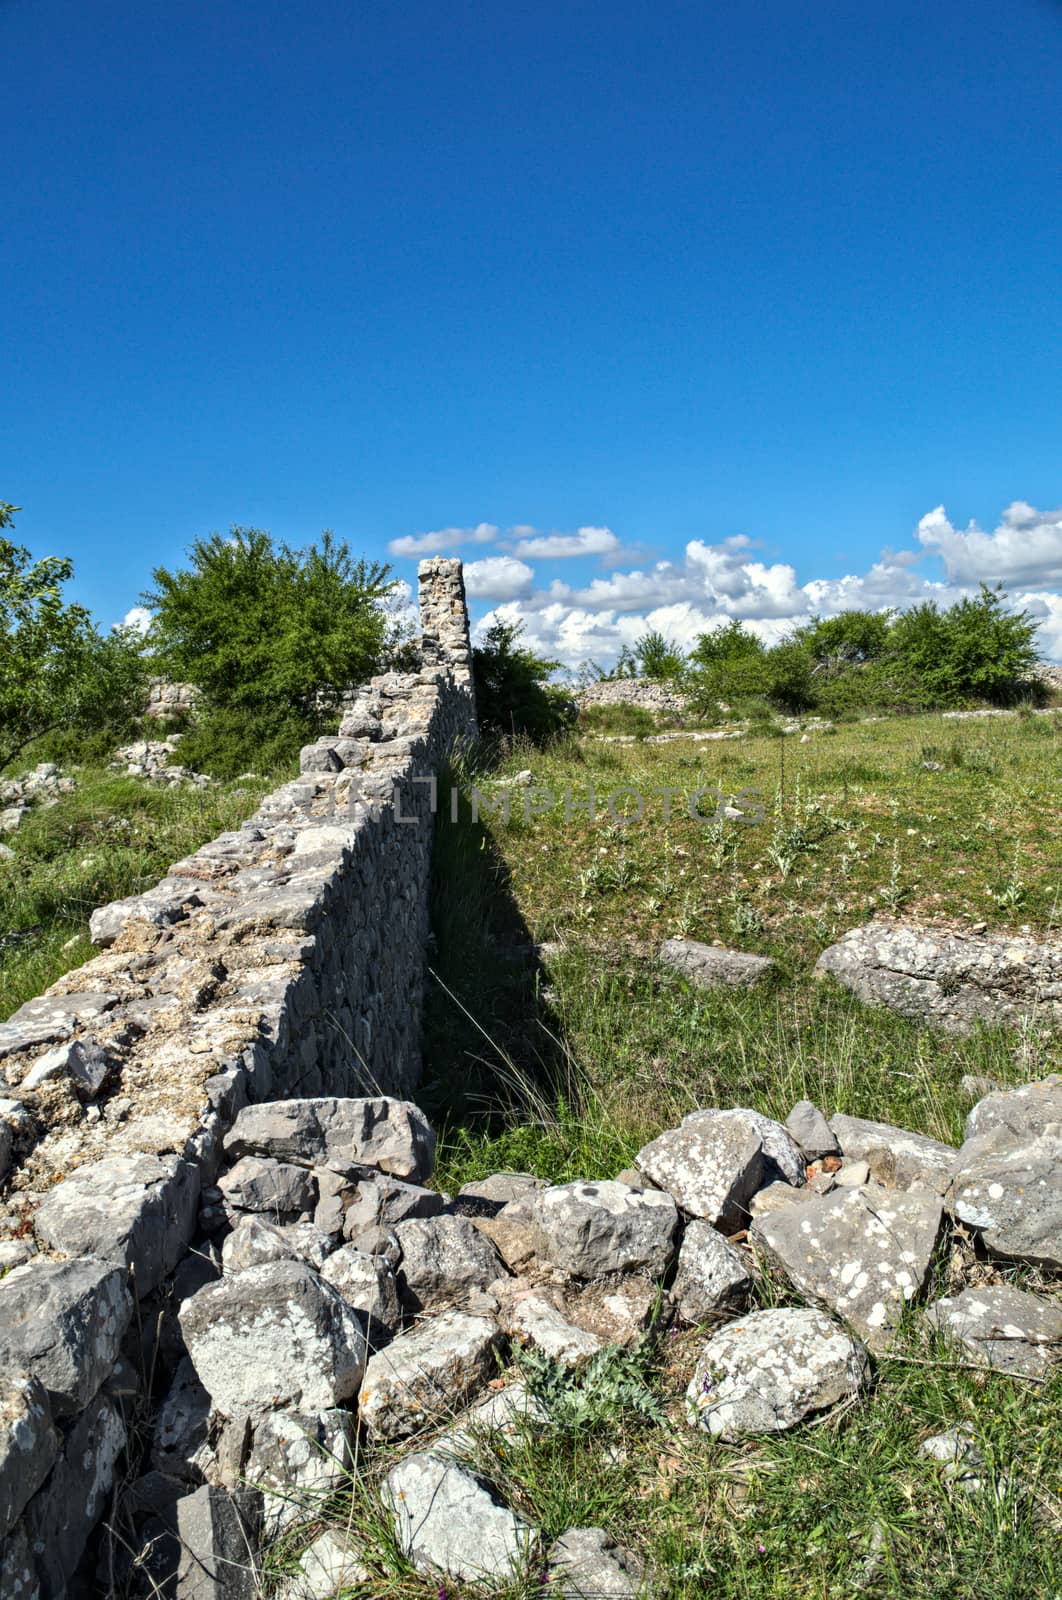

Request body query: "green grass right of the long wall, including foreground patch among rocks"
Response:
[315, 717, 1062, 1600]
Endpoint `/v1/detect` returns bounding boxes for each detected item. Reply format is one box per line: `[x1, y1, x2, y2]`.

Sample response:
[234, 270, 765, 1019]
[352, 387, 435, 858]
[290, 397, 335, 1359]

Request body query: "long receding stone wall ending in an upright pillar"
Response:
[0, 560, 475, 1597]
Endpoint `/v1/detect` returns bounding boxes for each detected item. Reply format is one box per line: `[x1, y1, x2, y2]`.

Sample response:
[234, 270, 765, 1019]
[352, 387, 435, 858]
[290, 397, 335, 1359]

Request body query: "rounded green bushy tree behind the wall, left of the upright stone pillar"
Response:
[144, 528, 393, 776]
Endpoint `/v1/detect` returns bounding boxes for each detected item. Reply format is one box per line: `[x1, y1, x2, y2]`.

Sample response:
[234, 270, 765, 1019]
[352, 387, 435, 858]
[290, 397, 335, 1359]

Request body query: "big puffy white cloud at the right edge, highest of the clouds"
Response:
[918, 501, 1062, 584]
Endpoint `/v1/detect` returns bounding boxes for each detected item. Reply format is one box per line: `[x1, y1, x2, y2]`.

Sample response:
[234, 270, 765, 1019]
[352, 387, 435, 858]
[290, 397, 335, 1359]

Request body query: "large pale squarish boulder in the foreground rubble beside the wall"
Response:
[179, 1261, 365, 1416]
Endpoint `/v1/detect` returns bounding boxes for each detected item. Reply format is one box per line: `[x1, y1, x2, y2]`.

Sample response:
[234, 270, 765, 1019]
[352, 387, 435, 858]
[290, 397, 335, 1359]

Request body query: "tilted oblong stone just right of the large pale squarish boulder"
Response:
[358, 1310, 502, 1438]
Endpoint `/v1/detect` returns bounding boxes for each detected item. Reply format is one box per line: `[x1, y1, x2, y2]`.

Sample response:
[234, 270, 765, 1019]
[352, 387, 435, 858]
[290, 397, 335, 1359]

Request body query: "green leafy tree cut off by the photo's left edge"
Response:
[0, 501, 147, 766]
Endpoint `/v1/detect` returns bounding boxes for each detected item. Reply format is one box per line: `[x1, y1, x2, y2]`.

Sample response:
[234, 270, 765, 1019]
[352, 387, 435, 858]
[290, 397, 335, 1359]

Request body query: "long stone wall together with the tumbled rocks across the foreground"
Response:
[0, 560, 1062, 1600]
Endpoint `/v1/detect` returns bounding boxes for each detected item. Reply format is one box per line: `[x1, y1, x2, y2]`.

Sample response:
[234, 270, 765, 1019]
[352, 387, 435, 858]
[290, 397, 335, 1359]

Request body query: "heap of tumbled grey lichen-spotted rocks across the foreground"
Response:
[0, 1075, 1062, 1600]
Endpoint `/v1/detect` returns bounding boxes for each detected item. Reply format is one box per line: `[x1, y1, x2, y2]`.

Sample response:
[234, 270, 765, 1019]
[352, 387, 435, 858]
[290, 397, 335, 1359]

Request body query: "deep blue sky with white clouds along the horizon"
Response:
[0, 0, 1062, 666]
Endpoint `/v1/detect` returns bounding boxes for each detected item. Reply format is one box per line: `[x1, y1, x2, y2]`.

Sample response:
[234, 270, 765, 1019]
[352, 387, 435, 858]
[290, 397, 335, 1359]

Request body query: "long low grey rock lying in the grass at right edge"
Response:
[814, 922, 1062, 1032]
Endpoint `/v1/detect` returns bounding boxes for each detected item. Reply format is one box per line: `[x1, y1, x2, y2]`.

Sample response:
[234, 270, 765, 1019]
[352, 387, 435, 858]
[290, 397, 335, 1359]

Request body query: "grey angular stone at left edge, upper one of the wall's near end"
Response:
[0, 1261, 133, 1416]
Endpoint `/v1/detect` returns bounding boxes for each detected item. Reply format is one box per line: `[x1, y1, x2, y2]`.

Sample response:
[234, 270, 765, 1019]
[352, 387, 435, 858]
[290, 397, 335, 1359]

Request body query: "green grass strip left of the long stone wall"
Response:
[0, 765, 275, 1021]
